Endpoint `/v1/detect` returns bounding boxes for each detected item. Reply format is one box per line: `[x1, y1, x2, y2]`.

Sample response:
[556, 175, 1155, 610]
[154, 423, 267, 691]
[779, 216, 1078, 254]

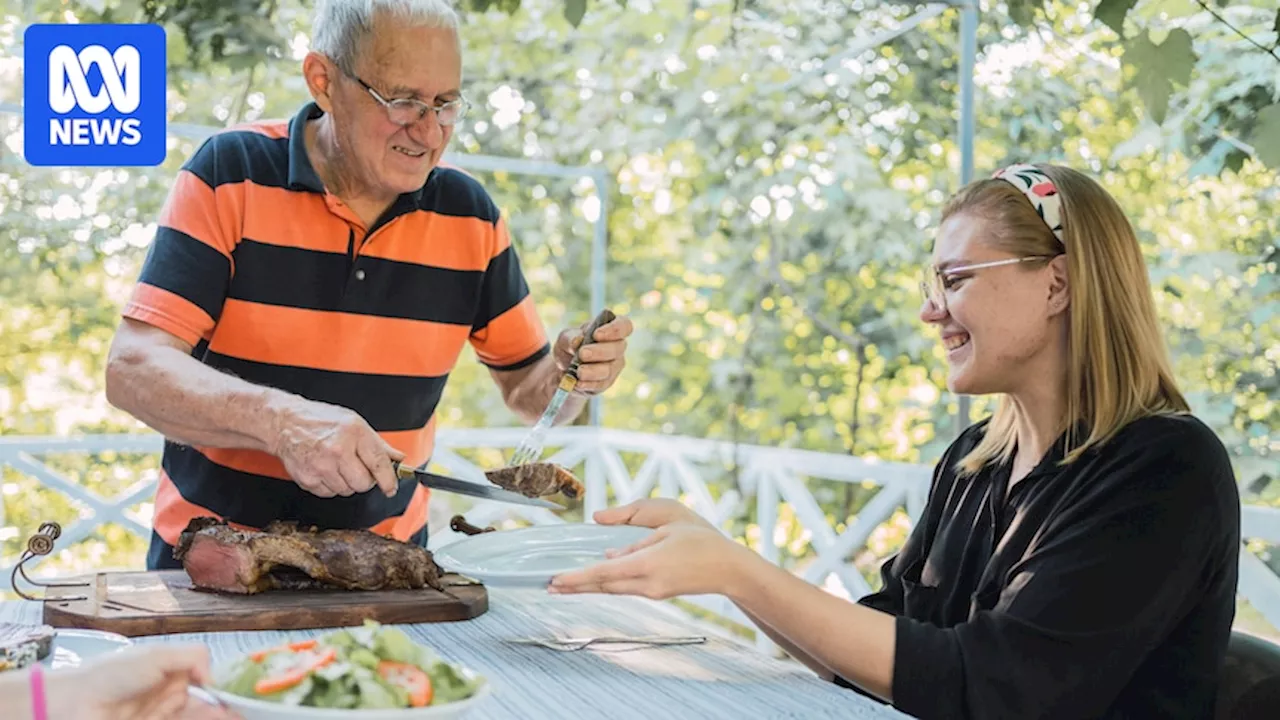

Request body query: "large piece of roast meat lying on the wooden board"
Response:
[173, 518, 443, 594]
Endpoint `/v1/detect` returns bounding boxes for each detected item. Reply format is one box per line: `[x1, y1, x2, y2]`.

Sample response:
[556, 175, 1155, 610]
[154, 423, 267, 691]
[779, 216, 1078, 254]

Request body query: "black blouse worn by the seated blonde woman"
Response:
[837, 415, 1240, 720]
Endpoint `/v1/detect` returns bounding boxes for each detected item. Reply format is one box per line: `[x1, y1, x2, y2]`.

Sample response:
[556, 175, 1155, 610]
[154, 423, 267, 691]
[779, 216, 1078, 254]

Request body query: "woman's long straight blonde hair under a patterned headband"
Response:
[942, 165, 1189, 474]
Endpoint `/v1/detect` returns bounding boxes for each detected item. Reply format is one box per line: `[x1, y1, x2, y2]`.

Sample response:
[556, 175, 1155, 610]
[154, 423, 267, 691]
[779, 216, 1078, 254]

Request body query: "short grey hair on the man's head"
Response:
[311, 0, 462, 74]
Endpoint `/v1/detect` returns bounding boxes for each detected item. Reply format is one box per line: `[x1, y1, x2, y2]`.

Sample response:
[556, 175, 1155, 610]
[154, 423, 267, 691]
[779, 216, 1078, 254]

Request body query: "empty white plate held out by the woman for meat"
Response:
[434, 523, 653, 588]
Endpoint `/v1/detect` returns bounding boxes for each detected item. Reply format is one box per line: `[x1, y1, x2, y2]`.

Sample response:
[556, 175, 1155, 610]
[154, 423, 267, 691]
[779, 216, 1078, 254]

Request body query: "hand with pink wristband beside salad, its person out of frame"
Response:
[45, 644, 238, 720]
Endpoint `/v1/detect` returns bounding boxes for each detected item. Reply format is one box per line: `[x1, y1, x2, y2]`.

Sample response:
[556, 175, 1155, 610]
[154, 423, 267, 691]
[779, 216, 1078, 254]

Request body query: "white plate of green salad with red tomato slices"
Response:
[218, 620, 484, 710]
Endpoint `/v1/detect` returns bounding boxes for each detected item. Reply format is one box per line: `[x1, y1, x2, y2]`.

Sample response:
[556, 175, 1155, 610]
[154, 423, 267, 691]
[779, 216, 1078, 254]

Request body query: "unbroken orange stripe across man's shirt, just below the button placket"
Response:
[209, 299, 470, 377]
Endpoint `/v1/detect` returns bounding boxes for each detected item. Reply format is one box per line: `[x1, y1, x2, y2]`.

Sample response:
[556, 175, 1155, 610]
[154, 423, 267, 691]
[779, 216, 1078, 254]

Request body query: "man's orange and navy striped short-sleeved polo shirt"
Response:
[123, 102, 550, 561]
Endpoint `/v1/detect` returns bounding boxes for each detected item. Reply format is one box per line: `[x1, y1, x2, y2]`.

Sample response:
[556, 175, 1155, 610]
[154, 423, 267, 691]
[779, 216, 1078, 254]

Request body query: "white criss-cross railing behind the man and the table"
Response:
[0, 427, 1280, 650]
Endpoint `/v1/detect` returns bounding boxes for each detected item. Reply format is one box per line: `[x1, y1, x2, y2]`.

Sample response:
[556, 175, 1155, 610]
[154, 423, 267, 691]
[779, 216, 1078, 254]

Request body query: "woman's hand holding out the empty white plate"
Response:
[548, 521, 759, 600]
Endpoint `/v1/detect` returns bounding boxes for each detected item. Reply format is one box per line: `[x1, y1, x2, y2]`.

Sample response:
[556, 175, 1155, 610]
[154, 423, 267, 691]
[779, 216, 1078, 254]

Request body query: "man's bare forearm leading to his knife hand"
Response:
[106, 347, 288, 452]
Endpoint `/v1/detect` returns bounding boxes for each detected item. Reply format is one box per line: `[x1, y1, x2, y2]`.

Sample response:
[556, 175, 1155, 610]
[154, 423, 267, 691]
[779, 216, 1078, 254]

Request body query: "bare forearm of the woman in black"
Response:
[724, 553, 896, 702]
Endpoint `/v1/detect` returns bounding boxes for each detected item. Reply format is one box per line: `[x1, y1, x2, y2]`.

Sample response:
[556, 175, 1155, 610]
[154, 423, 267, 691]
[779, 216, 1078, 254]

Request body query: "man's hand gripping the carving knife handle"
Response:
[271, 398, 404, 497]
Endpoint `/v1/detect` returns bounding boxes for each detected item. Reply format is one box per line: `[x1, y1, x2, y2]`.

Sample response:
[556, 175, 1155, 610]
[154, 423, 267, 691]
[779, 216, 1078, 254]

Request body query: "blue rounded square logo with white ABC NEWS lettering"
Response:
[22, 23, 168, 167]
